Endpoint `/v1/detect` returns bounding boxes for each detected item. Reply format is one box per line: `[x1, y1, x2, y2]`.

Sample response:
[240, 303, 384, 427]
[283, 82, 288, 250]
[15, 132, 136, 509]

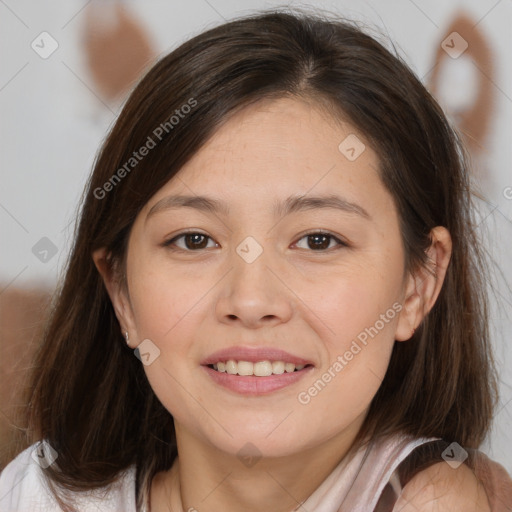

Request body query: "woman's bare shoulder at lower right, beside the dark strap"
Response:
[393, 462, 491, 512]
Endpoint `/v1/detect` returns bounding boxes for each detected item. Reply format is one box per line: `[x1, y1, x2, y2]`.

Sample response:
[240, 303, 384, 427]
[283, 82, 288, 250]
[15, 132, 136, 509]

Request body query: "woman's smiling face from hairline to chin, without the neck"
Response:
[119, 99, 411, 456]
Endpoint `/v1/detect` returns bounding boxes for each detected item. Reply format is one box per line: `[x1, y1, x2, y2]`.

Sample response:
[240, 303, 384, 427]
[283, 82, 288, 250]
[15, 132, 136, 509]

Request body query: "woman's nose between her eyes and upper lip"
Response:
[215, 242, 293, 329]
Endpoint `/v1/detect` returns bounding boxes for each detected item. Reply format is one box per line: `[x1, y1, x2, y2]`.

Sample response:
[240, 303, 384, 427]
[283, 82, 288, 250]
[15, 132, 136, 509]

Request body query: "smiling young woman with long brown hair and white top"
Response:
[0, 8, 512, 512]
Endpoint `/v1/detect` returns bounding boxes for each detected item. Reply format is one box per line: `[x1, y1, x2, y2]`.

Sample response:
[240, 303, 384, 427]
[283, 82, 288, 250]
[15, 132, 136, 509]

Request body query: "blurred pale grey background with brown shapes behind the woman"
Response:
[0, 0, 512, 474]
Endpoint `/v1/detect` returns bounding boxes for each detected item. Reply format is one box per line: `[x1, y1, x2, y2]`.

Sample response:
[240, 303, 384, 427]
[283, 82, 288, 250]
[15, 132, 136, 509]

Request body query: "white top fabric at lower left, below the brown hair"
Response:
[0, 442, 136, 512]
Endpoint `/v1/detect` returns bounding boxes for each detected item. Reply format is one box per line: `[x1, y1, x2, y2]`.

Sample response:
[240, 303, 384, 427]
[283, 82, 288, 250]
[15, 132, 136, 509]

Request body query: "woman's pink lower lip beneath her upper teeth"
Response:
[203, 366, 313, 396]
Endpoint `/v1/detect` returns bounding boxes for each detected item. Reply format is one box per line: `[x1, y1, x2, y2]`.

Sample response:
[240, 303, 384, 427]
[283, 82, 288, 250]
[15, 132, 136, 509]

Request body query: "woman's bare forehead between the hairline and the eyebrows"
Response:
[138, 98, 394, 228]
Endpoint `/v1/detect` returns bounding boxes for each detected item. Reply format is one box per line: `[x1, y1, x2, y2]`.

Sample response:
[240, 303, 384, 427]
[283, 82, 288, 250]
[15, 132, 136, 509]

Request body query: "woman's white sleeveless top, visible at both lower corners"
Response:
[0, 436, 432, 512]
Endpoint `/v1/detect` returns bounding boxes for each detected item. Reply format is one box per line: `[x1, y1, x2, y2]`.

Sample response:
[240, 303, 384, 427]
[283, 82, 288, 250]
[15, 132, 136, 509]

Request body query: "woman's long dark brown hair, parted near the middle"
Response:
[23, 6, 496, 510]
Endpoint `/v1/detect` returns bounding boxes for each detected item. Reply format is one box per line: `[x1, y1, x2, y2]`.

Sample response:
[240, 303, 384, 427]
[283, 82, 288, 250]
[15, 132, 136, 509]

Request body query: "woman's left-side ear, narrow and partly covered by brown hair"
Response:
[92, 247, 137, 343]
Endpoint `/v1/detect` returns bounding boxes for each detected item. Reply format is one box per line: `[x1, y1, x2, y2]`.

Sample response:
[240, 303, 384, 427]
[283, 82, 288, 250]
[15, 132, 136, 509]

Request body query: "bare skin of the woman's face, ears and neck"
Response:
[93, 98, 451, 512]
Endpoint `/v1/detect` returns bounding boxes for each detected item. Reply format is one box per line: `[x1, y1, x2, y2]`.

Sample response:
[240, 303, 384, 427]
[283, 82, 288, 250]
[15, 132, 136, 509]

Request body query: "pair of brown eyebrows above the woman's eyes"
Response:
[146, 194, 371, 221]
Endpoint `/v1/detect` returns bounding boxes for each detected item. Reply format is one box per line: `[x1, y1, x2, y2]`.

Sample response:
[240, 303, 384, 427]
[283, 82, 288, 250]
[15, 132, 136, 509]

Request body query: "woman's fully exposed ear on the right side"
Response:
[395, 226, 452, 341]
